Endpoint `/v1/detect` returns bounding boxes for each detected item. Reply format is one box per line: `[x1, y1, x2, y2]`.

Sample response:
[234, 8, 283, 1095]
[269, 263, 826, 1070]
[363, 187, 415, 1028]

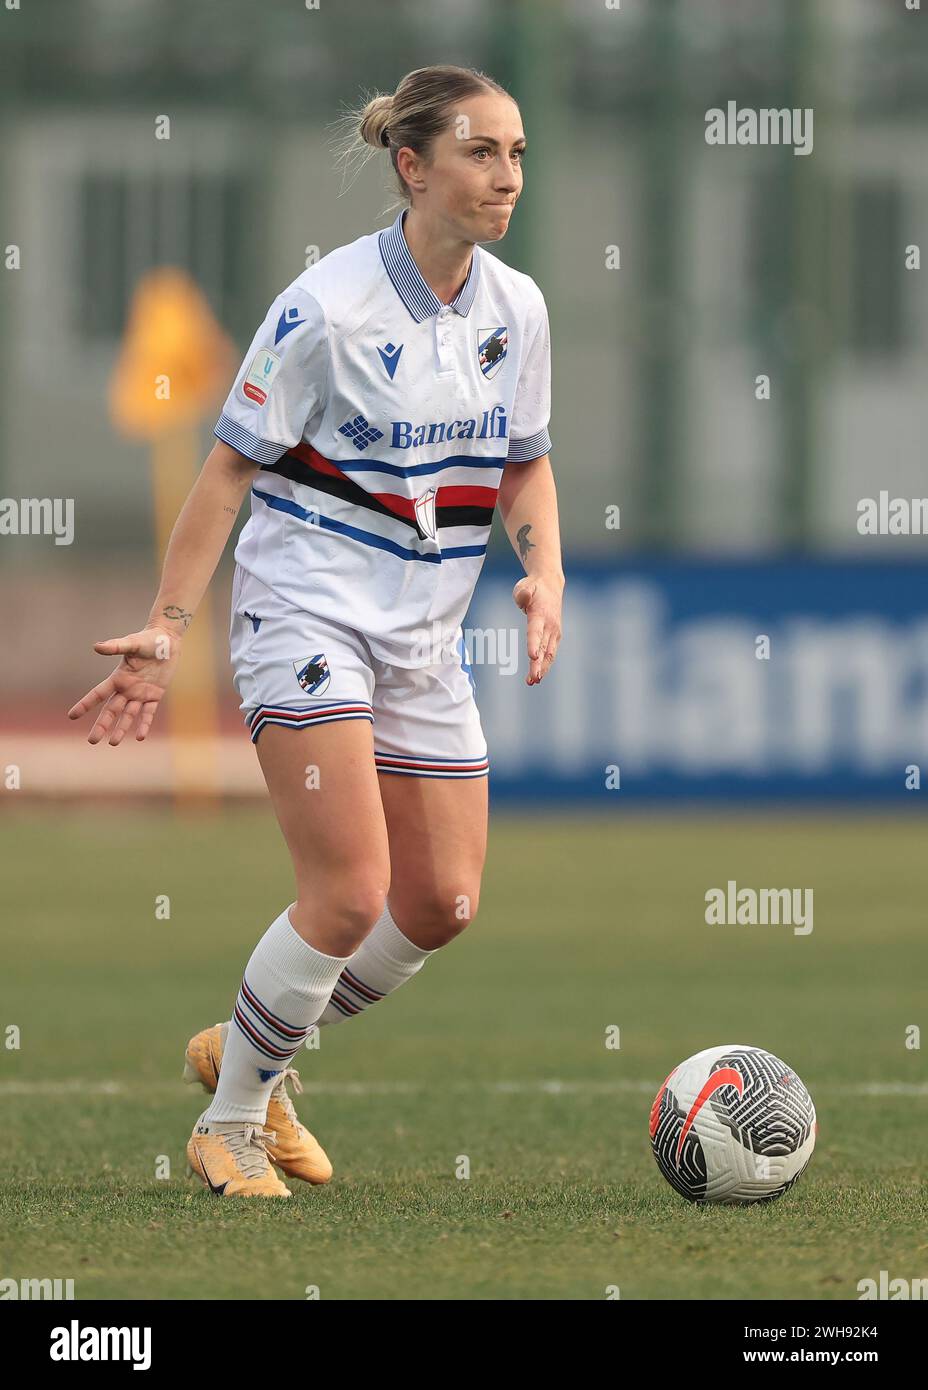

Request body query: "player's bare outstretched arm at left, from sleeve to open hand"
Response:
[68, 439, 258, 746]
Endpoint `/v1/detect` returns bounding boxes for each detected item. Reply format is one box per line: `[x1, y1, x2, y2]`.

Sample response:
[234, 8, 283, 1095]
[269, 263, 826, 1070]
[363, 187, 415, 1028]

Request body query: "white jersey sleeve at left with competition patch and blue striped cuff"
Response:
[213, 288, 329, 464]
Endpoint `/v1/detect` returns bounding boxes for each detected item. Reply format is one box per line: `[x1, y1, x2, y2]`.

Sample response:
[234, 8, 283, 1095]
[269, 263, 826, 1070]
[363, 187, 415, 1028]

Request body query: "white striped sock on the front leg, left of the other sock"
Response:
[203, 904, 351, 1125]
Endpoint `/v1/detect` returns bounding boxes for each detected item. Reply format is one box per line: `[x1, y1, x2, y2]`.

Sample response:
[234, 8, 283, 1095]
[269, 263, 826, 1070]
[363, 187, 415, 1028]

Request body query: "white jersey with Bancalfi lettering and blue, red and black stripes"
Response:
[214, 210, 552, 666]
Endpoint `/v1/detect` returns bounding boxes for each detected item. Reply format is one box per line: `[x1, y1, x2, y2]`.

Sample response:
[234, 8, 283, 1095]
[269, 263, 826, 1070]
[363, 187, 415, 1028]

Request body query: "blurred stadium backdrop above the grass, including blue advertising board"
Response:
[0, 0, 928, 802]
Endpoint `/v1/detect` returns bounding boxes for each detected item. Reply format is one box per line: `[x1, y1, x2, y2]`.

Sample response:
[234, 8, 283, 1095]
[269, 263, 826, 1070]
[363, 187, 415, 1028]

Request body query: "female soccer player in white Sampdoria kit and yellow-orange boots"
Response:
[69, 65, 564, 1197]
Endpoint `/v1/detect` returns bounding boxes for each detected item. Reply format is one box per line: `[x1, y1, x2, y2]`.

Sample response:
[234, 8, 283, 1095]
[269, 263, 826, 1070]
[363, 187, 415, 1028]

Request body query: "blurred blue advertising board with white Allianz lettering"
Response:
[464, 557, 928, 809]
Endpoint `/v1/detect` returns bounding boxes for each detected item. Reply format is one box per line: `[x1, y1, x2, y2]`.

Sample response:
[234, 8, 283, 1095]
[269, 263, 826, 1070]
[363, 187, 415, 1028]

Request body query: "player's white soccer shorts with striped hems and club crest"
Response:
[229, 564, 489, 777]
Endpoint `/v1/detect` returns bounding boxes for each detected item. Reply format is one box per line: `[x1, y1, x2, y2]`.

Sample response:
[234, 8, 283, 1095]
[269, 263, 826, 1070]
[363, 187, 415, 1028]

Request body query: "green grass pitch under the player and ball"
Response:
[0, 808, 928, 1300]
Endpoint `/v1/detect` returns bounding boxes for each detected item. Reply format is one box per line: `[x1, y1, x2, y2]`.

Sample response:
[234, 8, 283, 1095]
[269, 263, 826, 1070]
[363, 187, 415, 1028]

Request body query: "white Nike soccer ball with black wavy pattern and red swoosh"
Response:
[650, 1043, 817, 1204]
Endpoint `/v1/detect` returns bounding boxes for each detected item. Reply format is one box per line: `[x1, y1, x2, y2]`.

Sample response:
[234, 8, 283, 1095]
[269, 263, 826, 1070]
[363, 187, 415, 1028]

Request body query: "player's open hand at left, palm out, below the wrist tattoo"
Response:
[68, 627, 182, 748]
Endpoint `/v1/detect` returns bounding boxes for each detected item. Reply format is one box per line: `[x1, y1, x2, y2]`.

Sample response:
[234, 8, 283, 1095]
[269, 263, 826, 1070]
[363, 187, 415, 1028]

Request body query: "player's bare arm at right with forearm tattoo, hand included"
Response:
[497, 453, 564, 685]
